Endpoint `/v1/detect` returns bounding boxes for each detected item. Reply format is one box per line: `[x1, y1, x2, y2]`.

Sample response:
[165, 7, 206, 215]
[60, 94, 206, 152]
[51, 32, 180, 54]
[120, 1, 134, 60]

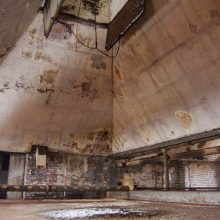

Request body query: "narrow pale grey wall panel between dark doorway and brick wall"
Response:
[7, 153, 25, 199]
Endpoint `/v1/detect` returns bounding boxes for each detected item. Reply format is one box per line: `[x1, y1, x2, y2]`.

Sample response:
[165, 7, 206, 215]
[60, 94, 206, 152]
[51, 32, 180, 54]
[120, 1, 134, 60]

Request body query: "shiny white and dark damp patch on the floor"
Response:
[41, 208, 161, 220]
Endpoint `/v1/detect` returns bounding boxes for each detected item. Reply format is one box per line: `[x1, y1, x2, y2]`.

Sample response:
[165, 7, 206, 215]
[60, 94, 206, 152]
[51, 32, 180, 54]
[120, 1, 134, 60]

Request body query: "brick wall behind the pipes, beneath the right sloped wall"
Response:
[117, 160, 220, 189]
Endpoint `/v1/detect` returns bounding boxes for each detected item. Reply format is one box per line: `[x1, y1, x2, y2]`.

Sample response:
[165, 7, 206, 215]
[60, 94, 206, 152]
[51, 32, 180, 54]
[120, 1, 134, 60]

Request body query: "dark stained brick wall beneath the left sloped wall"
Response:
[25, 152, 116, 198]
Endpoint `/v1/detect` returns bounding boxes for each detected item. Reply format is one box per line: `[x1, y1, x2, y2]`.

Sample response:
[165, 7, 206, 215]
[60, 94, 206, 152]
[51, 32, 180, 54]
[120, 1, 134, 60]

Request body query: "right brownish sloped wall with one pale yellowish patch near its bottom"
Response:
[113, 0, 220, 152]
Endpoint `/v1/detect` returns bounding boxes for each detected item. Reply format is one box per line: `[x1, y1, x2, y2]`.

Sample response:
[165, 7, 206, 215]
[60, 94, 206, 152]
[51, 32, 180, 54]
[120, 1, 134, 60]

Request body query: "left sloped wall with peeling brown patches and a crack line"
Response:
[0, 14, 112, 154]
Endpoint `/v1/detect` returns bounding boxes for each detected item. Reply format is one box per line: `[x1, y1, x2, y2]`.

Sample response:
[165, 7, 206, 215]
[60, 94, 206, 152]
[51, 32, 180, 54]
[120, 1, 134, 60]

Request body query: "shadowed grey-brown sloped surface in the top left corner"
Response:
[0, 0, 41, 63]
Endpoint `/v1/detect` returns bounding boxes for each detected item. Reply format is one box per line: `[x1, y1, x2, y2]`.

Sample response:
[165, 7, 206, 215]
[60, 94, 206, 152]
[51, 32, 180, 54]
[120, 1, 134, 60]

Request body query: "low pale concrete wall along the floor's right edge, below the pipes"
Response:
[107, 191, 220, 205]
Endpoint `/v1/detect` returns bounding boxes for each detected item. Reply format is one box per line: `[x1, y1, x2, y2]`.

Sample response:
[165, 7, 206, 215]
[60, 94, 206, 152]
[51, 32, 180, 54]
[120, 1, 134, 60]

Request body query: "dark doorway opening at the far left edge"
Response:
[0, 152, 10, 199]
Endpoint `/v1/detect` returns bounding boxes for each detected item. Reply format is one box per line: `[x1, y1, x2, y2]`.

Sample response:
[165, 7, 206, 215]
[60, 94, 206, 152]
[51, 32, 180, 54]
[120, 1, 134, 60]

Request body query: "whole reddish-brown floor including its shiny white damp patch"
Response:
[0, 200, 220, 220]
